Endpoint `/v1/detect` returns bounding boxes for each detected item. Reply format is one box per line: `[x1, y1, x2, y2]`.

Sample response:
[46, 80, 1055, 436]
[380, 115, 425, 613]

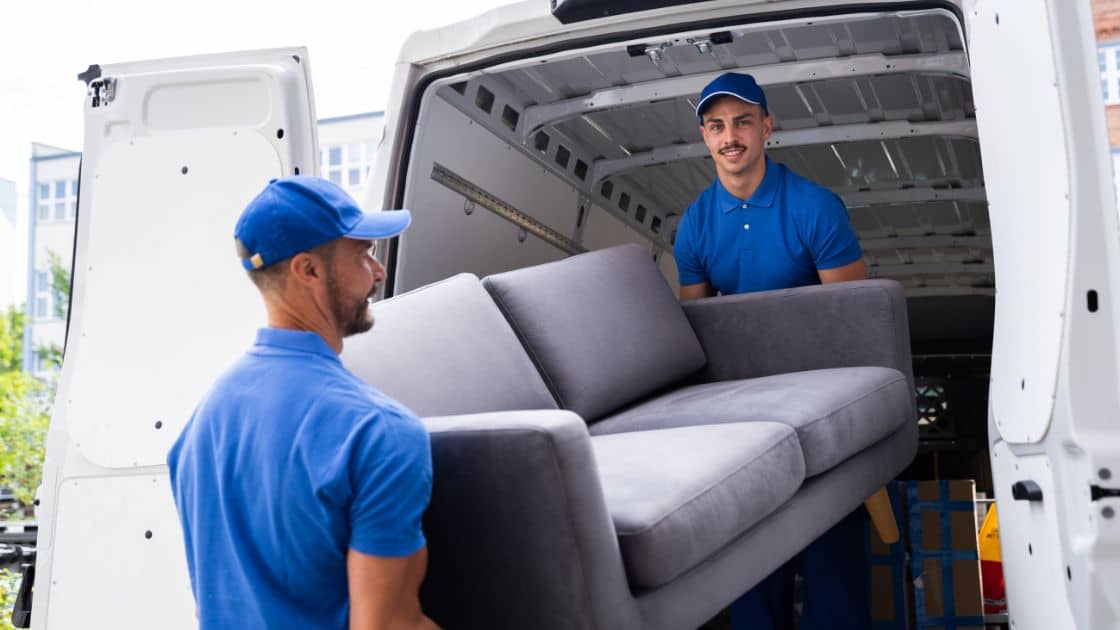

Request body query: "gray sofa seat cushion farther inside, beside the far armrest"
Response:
[591, 368, 915, 476]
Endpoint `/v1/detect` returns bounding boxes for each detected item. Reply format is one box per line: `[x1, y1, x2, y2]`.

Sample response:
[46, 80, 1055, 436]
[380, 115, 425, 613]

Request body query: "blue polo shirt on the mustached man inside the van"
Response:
[673, 157, 862, 295]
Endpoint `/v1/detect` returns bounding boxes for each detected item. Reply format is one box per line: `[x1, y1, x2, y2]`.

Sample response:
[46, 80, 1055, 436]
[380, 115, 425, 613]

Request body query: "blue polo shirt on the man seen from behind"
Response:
[167, 328, 431, 630]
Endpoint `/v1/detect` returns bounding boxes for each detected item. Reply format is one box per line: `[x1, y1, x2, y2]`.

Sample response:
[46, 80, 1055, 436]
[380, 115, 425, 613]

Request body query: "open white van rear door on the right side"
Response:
[964, 0, 1120, 630]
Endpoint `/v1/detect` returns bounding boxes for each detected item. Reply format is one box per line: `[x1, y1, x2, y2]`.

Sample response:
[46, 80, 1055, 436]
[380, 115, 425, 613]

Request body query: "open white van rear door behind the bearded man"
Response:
[32, 48, 318, 629]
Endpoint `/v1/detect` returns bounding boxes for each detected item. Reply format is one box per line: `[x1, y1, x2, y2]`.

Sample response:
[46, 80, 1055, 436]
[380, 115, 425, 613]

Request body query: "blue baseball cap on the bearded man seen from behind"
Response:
[233, 175, 412, 270]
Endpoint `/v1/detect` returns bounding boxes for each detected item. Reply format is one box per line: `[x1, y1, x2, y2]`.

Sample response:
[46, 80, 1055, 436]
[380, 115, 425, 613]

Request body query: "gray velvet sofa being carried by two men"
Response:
[343, 245, 917, 630]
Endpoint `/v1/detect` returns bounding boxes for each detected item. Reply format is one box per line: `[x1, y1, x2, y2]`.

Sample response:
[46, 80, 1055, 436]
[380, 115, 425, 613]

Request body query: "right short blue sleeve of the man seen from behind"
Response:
[349, 413, 431, 557]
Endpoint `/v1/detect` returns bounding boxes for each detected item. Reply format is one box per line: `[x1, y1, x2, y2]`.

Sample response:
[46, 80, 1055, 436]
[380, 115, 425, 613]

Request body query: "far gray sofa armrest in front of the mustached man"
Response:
[682, 280, 914, 388]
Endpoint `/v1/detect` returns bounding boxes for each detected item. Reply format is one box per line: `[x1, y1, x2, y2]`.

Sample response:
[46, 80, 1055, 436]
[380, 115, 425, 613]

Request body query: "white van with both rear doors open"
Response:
[24, 0, 1120, 630]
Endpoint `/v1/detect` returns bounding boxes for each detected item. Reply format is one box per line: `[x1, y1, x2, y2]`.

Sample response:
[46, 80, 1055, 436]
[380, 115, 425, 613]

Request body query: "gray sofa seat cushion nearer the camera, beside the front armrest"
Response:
[591, 423, 805, 589]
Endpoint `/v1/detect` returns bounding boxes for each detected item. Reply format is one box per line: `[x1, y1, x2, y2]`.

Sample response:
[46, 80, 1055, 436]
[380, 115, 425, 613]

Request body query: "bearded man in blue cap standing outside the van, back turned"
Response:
[168, 177, 435, 629]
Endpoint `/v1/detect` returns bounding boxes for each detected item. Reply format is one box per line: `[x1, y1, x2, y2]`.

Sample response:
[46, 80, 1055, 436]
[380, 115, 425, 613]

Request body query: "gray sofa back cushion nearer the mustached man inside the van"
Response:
[483, 245, 704, 421]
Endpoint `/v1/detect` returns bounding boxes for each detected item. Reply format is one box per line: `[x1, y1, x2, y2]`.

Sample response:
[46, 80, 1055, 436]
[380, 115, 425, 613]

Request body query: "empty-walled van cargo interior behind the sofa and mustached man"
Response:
[394, 8, 995, 486]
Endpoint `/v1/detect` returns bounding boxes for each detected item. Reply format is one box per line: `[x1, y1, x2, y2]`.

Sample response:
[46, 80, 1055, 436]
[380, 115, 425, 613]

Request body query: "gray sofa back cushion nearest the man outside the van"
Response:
[342, 274, 557, 416]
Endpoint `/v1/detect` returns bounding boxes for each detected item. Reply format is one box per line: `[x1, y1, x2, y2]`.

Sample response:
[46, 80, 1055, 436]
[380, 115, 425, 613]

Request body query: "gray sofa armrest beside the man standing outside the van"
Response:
[421, 410, 636, 628]
